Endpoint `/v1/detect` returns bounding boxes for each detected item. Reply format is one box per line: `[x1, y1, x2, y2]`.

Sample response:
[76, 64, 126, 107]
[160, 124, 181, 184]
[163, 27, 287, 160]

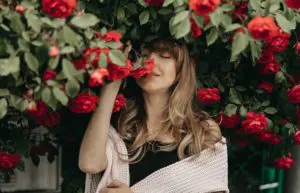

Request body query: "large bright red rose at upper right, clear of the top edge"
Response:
[248, 16, 278, 40]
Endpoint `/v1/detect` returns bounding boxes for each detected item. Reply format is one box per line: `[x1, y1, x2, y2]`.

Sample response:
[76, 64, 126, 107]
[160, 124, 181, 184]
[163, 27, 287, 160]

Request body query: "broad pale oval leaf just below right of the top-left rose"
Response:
[70, 13, 100, 28]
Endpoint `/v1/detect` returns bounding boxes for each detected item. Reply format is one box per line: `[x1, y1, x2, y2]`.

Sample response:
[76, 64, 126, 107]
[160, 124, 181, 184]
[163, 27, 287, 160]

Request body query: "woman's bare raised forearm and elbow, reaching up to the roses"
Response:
[79, 80, 122, 174]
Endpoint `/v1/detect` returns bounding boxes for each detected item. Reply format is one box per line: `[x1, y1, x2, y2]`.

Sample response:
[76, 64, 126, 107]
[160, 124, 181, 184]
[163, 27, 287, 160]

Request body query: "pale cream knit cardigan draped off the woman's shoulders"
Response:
[85, 127, 229, 193]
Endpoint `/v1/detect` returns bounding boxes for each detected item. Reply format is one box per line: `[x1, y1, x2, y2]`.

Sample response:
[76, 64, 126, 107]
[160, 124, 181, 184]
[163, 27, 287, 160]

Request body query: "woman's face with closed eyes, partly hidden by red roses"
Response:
[136, 49, 177, 93]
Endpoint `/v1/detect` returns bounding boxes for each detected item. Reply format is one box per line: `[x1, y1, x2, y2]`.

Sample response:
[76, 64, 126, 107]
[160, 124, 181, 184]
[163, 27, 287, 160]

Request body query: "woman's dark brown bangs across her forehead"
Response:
[143, 39, 182, 61]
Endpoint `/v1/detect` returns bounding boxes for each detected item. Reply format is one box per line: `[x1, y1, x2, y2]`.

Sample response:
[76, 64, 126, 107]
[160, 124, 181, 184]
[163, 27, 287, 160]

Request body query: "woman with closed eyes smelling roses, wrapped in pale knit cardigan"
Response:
[79, 39, 228, 193]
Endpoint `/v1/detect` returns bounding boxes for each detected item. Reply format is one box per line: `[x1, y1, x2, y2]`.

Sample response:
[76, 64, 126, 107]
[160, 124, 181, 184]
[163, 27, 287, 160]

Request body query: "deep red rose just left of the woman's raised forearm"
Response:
[69, 92, 98, 113]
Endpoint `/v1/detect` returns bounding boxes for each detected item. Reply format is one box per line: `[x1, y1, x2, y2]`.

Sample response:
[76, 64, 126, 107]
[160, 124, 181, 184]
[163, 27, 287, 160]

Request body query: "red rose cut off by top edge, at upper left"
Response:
[42, 0, 76, 18]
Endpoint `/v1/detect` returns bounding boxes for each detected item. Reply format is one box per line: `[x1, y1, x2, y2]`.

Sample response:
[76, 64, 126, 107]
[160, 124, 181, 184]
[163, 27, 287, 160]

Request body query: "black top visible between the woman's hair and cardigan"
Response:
[129, 149, 179, 186]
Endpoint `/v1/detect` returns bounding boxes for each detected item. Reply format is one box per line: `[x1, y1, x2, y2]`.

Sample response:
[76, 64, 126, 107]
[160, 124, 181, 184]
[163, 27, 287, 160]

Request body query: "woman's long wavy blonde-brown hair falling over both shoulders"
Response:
[116, 39, 221, 163]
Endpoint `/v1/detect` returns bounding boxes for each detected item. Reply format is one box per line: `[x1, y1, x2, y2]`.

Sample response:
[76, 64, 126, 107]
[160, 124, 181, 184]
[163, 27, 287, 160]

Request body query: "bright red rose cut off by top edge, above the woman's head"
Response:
[189, 0, 221, 15]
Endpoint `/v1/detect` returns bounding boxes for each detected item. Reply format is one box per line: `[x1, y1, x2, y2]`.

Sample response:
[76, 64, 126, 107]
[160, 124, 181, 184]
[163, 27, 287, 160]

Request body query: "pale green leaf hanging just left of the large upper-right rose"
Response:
[231, 33, 249, 57]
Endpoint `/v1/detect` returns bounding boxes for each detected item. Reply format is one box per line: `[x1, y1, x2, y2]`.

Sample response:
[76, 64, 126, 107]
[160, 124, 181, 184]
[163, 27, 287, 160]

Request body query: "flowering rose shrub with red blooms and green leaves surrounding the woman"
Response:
[0, 0, 300, 191]
